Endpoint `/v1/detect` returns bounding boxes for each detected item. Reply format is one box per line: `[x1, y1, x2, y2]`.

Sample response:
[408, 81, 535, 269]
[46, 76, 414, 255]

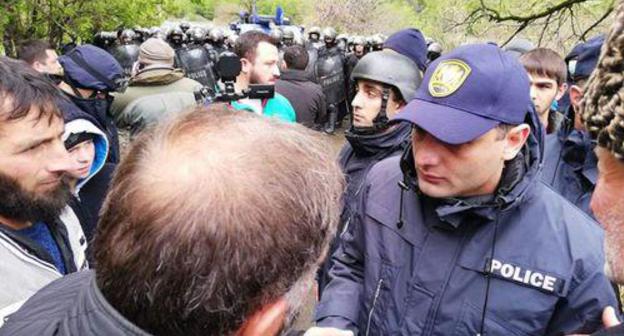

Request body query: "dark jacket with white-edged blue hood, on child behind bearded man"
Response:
[63, 119, 115, 241]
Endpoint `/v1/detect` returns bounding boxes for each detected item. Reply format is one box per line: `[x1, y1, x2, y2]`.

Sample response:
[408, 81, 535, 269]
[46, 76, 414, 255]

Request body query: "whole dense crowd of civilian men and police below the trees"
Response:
[0, 3, 624, 336]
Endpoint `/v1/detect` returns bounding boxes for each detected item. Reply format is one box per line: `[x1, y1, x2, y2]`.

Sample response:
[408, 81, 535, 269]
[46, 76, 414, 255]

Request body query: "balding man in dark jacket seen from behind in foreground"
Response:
[0, 104, 344, 336]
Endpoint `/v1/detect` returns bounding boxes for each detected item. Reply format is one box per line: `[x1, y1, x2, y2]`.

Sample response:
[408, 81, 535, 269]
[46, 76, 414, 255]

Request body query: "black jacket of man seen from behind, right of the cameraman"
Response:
[275, 70, 327, 129]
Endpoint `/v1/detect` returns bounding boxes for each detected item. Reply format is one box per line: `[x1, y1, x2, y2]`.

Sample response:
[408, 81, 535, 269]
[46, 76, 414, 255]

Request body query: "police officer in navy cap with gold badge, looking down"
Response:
[316, 44, 616, 335]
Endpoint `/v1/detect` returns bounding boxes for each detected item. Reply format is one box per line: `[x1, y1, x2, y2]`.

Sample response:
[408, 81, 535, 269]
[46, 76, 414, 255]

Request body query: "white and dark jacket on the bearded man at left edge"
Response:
[0, 207, 88, 326]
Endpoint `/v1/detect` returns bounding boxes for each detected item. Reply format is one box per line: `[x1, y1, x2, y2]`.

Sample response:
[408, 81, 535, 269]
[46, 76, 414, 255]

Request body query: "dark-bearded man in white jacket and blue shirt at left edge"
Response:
[0, 58, 87, 322]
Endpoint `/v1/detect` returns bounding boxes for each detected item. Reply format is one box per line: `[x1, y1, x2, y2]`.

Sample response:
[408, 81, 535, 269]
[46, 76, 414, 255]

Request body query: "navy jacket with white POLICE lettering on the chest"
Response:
[315, 109, 617, 335]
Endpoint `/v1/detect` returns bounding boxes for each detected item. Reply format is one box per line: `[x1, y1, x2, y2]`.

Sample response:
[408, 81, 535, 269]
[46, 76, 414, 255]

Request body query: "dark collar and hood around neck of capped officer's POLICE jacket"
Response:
[399, 106, 545, 226]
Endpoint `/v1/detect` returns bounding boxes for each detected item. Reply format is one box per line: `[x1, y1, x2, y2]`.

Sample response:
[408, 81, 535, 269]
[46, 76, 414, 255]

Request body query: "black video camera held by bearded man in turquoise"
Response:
[194, 51, 275, 104]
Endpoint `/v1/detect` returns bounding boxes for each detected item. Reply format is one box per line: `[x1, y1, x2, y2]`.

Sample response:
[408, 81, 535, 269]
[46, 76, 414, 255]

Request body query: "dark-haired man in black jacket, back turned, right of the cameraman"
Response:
[275, 45, 327, 130]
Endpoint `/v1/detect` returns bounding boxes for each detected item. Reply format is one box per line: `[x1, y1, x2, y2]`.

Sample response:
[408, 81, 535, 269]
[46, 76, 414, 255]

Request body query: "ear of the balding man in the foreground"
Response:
[236, 298, 288, 336]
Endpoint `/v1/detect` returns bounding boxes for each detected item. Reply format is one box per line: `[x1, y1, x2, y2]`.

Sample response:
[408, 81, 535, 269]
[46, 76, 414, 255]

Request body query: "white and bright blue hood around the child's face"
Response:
[63, 119, 109, 194]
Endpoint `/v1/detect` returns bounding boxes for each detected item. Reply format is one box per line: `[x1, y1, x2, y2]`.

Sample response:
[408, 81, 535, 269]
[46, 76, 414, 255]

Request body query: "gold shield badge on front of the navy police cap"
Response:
[429, 59, 472, 98]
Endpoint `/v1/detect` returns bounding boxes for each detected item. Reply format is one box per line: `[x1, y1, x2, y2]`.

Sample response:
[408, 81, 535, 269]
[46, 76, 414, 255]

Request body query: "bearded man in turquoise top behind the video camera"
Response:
[231, 31, 296, 122]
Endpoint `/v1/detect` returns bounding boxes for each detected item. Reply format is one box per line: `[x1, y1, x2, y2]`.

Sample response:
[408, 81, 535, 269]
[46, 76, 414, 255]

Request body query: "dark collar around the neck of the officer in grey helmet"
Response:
[345, 123, 412, 156]
